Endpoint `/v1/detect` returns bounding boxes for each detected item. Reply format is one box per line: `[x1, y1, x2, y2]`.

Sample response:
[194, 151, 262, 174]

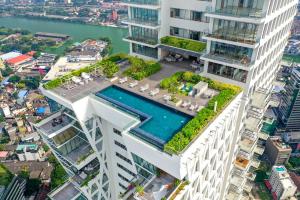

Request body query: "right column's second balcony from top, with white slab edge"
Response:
[203, 28, 258, 48]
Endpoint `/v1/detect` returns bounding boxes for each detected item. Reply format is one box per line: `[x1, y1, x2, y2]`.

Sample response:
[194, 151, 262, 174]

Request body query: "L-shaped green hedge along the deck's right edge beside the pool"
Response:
[160, 72, 241, 154]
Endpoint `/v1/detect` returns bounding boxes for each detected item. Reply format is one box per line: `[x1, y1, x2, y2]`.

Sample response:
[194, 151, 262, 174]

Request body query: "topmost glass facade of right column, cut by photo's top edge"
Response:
[216, 0, 264, 18]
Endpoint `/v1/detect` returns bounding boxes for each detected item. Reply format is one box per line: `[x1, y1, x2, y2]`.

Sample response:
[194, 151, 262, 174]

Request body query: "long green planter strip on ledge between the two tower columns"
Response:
[160, 36, 206, 52]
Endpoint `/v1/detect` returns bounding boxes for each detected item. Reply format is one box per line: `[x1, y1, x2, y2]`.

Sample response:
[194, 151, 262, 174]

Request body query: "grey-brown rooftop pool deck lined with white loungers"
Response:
[47, 62, 217, 116]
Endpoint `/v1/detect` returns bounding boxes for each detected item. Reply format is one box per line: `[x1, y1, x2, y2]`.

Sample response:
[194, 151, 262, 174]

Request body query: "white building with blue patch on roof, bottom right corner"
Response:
[269, 166, 297, 199]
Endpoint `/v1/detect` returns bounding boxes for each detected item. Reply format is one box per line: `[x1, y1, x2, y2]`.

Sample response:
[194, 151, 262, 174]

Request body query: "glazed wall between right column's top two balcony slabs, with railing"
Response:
[210, 19, 258, 44]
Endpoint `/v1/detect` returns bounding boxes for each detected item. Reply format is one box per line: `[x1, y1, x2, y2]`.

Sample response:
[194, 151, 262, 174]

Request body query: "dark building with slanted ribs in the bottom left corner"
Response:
[0, 177, 26, 200]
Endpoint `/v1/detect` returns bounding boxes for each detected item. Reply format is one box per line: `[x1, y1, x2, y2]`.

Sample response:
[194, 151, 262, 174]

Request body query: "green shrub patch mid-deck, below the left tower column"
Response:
[123, 57, 161, 80]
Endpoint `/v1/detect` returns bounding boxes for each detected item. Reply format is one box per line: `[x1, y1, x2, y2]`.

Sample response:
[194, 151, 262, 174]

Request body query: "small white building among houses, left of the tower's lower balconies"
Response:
[16, 144, 43, 161]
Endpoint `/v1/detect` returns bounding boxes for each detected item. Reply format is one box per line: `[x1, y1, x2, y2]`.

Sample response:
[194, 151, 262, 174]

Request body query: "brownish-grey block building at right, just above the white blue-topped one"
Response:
[265, 137, 292, 165]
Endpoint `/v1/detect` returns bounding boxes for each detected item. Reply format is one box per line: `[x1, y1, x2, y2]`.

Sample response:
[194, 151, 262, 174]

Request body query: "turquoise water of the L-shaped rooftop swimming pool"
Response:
[96, 86, 192, 143]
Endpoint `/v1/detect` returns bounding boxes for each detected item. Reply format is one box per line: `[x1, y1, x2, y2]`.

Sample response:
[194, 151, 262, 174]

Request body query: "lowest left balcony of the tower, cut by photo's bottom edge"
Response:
[48, 181, 85, 200]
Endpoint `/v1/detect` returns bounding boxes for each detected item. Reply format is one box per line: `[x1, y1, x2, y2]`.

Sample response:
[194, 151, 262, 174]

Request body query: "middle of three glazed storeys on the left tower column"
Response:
[129, 26, 158, 45]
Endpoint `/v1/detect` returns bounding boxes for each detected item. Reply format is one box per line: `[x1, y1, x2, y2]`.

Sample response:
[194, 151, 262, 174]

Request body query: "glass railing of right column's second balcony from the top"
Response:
[207, 27, 258, 45]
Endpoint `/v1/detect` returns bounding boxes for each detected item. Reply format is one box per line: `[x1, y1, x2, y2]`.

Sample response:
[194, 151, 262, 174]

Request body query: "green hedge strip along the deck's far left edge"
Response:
[43, 54, 127, 90]
